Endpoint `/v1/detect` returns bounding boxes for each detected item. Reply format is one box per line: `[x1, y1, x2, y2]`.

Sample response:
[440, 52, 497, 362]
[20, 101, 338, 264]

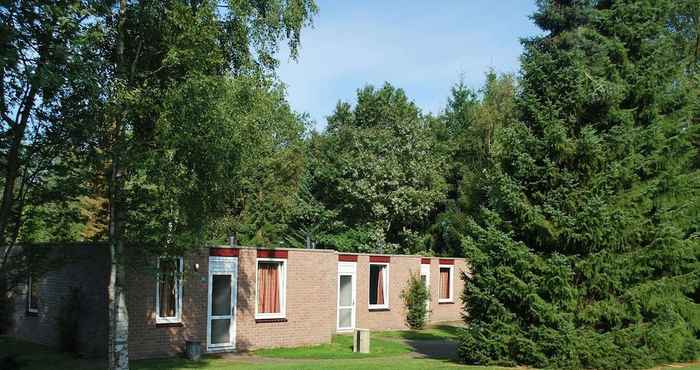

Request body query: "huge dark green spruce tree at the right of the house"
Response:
[459, 0, 700, 368]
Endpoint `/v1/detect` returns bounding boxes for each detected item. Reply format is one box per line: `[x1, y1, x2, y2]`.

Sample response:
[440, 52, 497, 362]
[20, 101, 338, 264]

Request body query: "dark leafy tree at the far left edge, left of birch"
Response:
[0, 1, 110, 334]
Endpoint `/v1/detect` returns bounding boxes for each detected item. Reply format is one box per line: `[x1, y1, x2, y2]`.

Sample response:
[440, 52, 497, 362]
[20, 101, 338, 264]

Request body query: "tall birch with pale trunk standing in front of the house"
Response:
[50, 0, 317, 369]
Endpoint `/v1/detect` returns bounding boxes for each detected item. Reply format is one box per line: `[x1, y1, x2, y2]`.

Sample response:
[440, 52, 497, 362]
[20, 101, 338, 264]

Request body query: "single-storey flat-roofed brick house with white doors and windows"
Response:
[8, 245, 468, 359]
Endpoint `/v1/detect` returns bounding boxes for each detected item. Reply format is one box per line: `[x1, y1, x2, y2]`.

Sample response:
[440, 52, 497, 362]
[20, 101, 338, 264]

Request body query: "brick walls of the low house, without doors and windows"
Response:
[8, 246, 468, 359]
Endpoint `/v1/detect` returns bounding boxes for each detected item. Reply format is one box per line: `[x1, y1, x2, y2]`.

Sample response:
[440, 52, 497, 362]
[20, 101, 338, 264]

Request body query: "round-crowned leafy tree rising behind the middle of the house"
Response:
[313, 84, 446, 253]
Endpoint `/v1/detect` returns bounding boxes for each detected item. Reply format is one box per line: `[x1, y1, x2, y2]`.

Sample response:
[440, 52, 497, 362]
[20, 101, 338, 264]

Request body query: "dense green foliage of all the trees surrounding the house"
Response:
[0, 0, 700, 368]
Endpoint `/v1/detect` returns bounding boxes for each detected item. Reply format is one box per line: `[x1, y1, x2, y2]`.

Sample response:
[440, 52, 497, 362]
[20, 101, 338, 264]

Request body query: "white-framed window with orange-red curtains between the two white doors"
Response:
[255, 259, 287, 319]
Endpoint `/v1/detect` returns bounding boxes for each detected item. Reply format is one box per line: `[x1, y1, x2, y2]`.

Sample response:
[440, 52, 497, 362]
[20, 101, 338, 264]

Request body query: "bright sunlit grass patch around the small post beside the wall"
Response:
[255, 335, 411, 360]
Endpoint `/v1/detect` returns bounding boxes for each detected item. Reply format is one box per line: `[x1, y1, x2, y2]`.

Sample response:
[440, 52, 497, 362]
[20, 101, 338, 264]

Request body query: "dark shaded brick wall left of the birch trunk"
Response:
[12, 245, 109, 357]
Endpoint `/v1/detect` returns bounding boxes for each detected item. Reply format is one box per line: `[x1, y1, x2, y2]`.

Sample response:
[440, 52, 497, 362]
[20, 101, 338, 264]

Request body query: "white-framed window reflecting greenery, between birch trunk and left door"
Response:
[156, 257, 182, 323]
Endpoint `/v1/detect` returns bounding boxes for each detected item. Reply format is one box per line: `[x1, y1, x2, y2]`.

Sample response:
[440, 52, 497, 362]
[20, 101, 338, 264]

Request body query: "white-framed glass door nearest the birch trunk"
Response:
[207, 257, 238, 351]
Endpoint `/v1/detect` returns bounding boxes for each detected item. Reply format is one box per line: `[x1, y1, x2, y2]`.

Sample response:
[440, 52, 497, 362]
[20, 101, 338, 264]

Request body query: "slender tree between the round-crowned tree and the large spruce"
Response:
[429, 71, 516, 256]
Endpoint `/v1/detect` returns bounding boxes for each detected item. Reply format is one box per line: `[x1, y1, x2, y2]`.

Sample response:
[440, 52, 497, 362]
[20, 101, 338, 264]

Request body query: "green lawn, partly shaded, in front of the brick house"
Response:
[0, 336, 700, 370]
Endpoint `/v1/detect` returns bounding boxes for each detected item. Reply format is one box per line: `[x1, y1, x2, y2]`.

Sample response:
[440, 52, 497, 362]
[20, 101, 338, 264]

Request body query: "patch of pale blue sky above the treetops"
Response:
[278, 0, 539, 130]
